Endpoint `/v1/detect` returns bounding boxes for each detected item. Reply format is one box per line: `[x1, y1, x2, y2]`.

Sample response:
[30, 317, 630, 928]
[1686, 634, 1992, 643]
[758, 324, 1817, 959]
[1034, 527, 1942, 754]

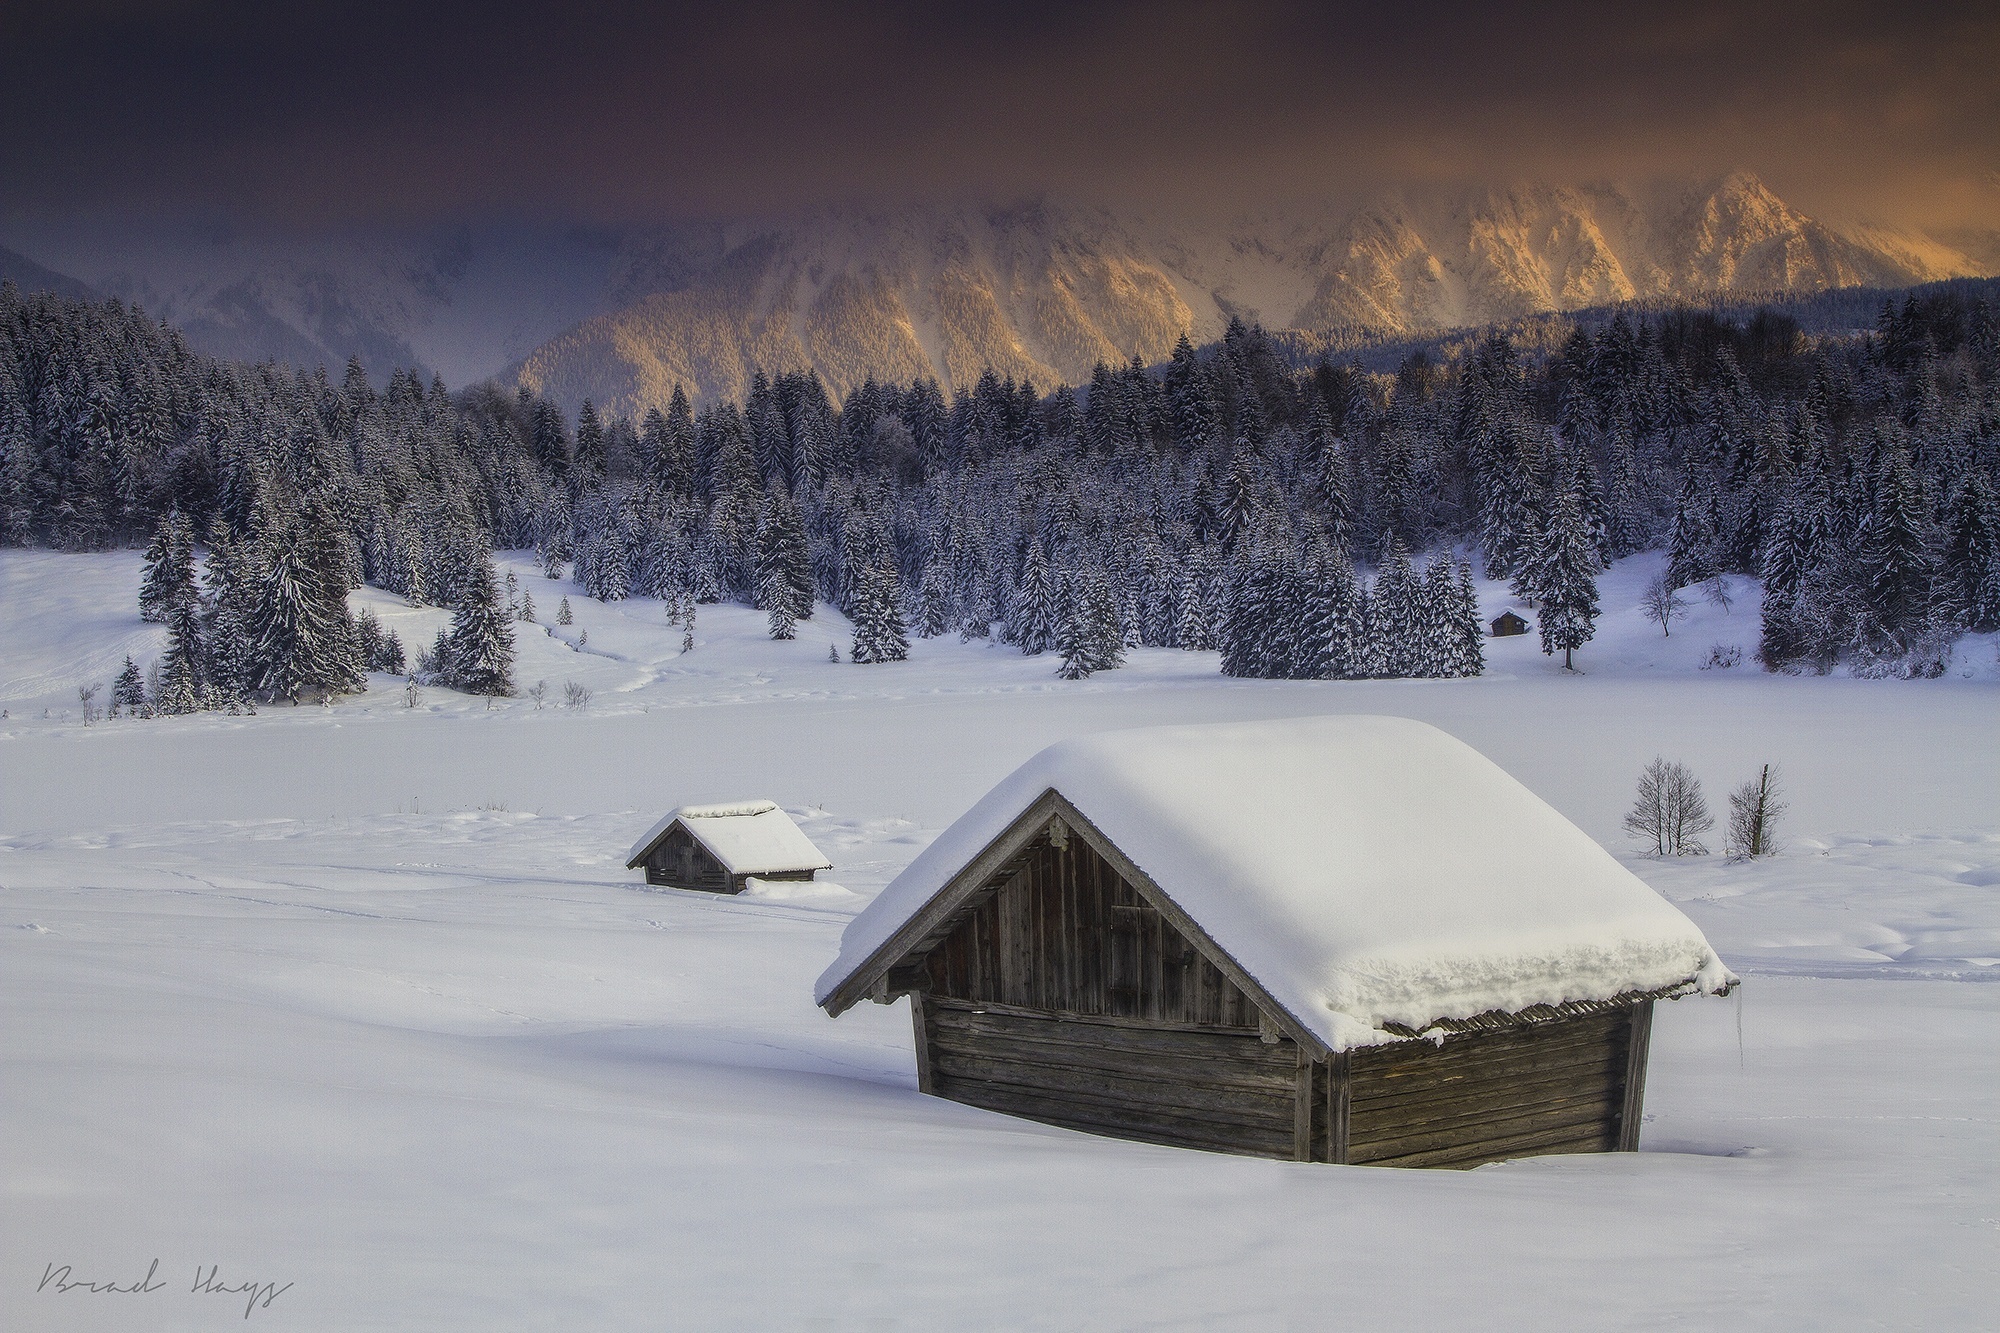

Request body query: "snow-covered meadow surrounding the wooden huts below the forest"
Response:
[0, 550, 2000, 1329]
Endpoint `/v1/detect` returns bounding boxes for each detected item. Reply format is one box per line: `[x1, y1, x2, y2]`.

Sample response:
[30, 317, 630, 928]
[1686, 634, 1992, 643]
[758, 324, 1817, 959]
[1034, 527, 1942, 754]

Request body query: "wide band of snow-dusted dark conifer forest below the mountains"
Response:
[0, 284, 2000, 713]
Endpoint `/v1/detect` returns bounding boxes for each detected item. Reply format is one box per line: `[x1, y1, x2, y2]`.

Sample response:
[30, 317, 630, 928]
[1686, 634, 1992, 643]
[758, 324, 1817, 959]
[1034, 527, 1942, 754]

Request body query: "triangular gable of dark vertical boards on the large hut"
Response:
[922, 835, 1258, 1029]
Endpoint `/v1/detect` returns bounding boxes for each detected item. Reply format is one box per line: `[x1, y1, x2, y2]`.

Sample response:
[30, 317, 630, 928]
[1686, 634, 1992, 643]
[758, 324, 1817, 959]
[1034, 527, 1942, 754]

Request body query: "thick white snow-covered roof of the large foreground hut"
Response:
[816, 717, 1734, 1051]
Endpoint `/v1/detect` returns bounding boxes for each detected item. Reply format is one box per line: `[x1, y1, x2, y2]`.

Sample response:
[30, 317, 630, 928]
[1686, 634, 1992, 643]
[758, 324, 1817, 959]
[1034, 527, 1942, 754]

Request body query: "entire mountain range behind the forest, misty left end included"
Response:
[0, 172, 1986, 414]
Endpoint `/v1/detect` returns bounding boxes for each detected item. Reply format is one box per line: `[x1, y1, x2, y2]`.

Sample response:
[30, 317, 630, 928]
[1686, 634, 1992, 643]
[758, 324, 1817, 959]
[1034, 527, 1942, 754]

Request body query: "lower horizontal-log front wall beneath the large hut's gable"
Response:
[910, 995, 1296, 1159]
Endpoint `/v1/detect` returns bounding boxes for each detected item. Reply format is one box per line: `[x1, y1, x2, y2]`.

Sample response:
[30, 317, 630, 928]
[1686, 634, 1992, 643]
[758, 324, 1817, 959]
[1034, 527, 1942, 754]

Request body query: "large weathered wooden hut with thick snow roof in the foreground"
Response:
[816, 717, 1736, 1167]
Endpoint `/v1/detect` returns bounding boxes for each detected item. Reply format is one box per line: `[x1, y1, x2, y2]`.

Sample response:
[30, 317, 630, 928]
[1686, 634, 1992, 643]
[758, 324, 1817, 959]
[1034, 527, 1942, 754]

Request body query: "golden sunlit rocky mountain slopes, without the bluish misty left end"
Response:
[514, 172, 1980, 412]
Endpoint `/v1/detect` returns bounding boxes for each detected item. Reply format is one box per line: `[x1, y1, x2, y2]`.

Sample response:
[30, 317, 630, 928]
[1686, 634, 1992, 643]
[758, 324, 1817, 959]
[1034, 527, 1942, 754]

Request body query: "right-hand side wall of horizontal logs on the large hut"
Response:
[1346, 1009, 1644, 1167]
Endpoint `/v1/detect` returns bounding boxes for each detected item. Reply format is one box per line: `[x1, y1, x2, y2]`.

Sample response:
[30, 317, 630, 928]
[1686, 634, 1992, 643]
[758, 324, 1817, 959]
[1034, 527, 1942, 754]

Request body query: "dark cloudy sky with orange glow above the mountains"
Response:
[0, 0, 2000, 230]
